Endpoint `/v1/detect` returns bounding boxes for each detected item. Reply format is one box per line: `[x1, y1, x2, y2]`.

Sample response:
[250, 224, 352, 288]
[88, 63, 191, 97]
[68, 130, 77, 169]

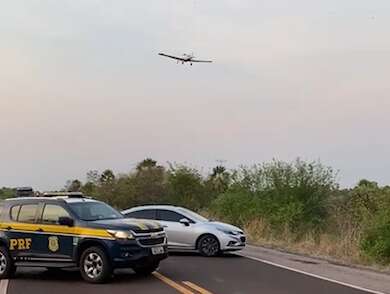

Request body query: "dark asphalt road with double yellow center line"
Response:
[0, 254, 384, 294]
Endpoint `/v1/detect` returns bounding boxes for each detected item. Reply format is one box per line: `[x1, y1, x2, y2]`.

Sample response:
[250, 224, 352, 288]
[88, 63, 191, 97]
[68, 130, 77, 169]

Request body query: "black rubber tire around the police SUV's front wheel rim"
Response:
[80, 247, 112, 284]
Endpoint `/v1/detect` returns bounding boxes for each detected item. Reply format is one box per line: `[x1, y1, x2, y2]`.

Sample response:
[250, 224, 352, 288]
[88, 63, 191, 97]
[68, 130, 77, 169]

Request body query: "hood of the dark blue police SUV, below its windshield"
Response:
[88, 218, 163, 233]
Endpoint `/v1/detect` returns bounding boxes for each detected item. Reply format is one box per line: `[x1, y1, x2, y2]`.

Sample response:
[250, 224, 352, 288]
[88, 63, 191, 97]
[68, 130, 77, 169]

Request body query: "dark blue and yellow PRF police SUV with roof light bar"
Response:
[0, 193, 167, 283]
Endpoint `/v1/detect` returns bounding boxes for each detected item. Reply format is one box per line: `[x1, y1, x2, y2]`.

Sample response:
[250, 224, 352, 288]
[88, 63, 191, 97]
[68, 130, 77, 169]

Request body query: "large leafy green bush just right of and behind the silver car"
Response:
[212, 160, 337, 233]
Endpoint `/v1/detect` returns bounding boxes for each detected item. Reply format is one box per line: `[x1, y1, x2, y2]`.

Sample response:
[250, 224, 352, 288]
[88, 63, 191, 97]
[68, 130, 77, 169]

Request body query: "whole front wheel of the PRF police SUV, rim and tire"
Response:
[80, 247, 112, 283]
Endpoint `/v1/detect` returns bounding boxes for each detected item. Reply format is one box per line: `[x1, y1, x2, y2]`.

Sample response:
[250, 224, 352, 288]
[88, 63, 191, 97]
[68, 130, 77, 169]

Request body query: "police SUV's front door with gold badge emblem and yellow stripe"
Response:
[37, 203, 74, 262]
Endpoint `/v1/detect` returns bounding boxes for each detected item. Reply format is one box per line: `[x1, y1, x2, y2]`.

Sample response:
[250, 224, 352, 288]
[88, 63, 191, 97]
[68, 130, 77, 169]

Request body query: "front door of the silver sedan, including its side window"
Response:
[156, 209, 196, 249]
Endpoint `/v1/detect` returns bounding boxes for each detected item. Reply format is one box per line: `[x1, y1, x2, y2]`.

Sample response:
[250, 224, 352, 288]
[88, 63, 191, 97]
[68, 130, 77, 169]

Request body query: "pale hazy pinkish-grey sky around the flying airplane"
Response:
[0, 0, 390, 190]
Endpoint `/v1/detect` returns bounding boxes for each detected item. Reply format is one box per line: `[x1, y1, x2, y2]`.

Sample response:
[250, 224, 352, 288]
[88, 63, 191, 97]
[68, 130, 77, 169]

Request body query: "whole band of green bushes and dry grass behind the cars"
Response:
[0, 159, 390, 268]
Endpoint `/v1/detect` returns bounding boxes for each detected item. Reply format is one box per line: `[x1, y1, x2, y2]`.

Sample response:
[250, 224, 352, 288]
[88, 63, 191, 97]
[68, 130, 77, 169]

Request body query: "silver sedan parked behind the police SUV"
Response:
[122, 205, 246, 256]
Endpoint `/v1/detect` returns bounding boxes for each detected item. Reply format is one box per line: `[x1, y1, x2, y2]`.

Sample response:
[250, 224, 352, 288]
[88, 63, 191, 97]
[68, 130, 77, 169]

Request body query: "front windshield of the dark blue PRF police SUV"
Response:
[69, 202, 123, 221]
